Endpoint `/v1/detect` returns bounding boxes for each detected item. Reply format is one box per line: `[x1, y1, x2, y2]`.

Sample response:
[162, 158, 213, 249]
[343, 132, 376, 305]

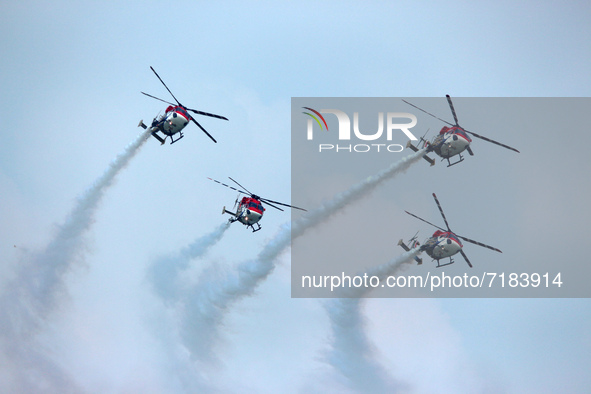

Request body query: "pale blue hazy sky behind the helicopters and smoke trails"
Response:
[0, 1, 591, 393]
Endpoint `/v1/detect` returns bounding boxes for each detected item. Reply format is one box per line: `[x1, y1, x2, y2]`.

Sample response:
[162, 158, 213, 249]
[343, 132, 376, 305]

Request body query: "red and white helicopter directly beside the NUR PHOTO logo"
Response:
[402, 94, 519, 167]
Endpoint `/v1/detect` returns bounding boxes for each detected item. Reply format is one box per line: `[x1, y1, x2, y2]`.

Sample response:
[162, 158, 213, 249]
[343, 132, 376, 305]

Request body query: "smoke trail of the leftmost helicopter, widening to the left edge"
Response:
[0, 131, 149, 392]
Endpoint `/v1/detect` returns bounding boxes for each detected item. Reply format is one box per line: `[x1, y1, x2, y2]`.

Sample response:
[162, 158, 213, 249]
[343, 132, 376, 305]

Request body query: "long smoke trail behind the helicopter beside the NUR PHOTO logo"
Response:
[181, 150, 425, 361]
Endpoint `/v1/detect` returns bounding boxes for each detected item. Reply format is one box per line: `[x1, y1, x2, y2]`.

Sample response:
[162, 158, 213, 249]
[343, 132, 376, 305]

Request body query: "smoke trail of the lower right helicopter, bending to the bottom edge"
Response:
[324, 248, 419, 393]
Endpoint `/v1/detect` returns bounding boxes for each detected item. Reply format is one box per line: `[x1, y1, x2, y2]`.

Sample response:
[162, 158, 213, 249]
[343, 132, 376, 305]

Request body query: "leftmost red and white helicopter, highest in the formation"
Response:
[138, 66, 228, 145]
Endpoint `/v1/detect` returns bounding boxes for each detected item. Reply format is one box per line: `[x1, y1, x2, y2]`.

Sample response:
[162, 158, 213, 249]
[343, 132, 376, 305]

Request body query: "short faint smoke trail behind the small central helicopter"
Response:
[148, 221, 230, 303]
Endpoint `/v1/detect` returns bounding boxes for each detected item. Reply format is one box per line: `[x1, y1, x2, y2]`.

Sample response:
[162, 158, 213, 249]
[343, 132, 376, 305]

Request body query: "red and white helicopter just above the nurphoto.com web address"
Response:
[398, 193, 503, 268]
